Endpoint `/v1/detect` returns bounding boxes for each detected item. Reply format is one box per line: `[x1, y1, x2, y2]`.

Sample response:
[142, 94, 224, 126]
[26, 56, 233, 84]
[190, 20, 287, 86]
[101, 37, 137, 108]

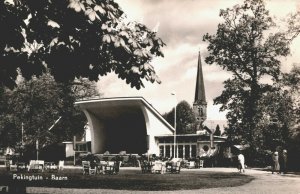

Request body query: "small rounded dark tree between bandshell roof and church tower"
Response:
[163, 100, 196, 134]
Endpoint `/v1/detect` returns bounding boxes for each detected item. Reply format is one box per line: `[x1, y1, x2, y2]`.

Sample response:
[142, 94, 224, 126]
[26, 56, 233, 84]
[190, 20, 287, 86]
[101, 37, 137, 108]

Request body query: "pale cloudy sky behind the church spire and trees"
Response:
[97, 0, 300, 120]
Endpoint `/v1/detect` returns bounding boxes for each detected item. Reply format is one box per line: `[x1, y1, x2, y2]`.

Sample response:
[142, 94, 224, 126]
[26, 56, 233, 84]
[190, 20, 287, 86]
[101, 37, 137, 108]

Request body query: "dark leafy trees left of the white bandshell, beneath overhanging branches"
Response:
[0, 74, 99, 150]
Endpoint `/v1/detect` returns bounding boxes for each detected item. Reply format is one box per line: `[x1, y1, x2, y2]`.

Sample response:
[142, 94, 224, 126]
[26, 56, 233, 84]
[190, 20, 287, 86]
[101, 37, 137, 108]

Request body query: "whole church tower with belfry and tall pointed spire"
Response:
[193, 51, 207, 130]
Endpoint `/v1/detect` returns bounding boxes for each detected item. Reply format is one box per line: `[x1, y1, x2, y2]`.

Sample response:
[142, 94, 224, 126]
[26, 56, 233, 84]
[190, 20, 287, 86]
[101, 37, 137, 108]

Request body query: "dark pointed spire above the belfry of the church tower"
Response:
[194, 51, 206, 103]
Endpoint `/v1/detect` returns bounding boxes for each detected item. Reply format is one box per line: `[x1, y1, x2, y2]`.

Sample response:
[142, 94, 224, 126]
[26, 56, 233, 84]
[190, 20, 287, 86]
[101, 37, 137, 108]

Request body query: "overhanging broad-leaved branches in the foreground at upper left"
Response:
[0, 0, 164, 89]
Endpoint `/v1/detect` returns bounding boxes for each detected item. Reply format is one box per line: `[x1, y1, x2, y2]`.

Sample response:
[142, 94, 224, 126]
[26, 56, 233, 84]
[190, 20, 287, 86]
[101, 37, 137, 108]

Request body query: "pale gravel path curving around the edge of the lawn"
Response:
[27, 168, 300, 194]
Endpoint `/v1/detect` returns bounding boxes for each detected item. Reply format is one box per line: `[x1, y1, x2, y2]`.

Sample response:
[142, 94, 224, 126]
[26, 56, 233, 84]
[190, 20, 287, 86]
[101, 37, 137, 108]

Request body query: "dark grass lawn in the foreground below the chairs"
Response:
[0, 169, 254, 191]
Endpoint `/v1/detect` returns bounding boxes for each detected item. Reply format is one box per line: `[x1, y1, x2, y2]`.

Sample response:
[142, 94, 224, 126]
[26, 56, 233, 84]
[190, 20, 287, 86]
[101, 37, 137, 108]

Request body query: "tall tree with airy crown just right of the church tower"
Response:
[203, 0, 298, 147]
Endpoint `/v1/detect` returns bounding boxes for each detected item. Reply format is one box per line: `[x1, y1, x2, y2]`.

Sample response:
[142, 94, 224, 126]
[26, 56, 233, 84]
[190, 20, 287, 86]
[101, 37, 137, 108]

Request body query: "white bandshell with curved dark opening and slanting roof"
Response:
[75, 97, 174, 155]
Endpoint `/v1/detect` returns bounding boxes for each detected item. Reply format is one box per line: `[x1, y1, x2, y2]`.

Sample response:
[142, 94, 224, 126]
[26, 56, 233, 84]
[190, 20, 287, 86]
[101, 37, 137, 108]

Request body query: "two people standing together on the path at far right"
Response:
[272, 149, 287, 174]
